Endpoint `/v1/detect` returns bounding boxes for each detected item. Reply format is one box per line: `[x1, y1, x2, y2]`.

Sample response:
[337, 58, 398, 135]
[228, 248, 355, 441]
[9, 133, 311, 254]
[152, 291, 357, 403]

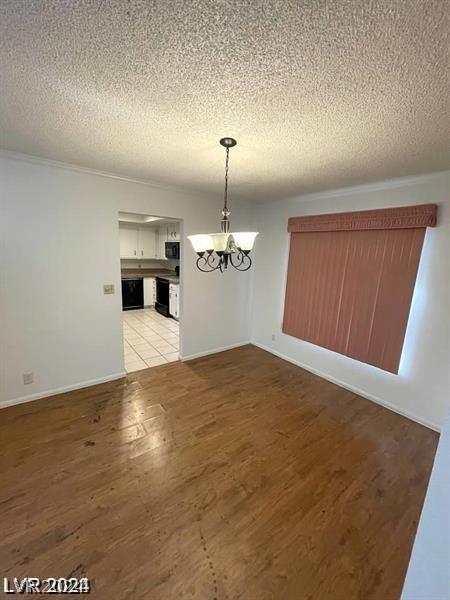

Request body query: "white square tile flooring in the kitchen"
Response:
[123, 308, 180, 373]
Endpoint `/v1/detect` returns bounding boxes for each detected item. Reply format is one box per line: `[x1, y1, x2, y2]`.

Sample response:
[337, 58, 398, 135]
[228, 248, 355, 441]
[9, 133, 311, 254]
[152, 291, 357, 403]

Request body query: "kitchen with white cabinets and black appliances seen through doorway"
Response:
[119, 213, 182, 373]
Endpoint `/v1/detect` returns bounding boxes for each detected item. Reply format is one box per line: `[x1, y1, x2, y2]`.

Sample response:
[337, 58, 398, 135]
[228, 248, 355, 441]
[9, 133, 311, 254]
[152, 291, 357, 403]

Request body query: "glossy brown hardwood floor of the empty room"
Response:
[0, 346, 438, 600]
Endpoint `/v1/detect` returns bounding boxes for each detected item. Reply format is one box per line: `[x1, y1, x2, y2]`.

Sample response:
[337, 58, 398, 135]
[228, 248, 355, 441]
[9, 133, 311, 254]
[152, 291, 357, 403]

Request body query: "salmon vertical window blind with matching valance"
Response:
[283, 204, 436, 373]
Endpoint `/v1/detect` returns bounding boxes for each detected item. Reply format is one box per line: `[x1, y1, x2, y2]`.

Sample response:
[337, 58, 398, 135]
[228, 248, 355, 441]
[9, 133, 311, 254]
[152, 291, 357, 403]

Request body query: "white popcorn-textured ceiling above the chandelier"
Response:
[0, 0, 450, 200]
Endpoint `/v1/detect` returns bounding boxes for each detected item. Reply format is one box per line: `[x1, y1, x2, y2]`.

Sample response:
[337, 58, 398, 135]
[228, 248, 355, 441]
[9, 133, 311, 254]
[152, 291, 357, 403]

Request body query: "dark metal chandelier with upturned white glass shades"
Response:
[187, 137, 258, 273]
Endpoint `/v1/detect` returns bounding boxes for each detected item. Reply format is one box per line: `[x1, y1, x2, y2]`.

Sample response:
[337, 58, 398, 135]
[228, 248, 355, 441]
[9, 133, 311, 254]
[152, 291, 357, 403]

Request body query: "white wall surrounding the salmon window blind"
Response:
[251, 172, 450, 429]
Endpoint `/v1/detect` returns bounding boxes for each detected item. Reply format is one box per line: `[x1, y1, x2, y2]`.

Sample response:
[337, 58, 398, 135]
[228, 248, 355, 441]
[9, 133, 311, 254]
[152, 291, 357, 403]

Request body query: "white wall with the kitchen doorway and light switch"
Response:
[0, 155, 250, 403]
